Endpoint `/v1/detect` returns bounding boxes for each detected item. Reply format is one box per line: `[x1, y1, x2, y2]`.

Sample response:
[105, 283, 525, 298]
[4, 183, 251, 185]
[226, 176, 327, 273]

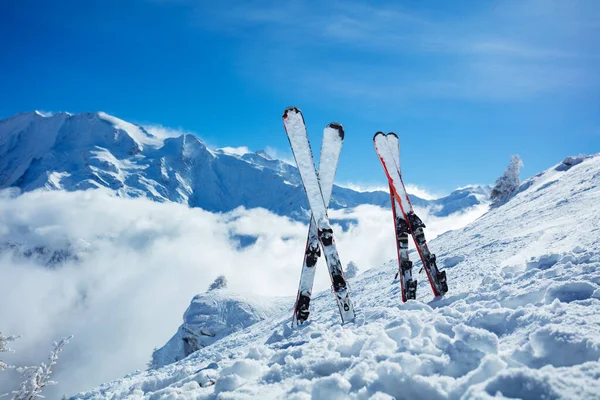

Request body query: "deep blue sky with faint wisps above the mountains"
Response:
[0, 0, 600, 193]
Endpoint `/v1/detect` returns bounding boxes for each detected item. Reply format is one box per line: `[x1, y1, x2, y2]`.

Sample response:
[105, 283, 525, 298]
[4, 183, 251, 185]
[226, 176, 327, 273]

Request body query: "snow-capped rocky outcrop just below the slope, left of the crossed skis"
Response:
[151, 289, 290, 368]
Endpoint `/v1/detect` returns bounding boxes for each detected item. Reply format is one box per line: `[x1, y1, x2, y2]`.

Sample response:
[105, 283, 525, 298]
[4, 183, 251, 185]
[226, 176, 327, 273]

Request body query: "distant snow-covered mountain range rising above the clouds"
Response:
[0, 112, 489, 220]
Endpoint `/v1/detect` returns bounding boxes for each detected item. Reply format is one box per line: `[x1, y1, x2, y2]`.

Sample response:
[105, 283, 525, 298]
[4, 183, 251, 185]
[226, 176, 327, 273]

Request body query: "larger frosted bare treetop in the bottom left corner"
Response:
[13, 336, 73, 400]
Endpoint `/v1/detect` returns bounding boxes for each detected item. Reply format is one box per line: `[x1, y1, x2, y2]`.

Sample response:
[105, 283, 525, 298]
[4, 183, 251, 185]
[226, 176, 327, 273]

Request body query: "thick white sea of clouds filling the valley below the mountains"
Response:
[0, 189, 487, 395]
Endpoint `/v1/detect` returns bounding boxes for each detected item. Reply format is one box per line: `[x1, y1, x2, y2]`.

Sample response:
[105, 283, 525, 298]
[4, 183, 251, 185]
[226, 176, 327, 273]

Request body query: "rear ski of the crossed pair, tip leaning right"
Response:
[292, 123, 344, 327]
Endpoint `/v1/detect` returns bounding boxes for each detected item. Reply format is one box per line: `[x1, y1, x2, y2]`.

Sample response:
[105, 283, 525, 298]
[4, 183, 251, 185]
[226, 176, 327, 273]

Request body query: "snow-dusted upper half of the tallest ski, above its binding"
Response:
[283, 109, 329, 228]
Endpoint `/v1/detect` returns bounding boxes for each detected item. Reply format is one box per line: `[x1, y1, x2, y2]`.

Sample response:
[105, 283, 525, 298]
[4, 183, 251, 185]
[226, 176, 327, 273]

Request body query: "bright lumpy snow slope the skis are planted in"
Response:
[74, 155, 600, 399]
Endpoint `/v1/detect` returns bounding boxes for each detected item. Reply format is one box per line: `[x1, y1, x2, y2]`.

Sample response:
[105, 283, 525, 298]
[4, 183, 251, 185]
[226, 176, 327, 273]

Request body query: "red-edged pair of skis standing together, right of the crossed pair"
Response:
[373, 132, 448, 301]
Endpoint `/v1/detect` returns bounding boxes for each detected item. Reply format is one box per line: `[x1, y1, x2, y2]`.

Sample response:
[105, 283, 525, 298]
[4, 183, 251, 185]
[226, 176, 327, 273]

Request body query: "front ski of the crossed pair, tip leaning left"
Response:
[283, 107, 355, 323]
